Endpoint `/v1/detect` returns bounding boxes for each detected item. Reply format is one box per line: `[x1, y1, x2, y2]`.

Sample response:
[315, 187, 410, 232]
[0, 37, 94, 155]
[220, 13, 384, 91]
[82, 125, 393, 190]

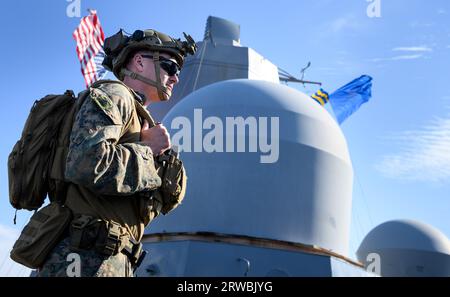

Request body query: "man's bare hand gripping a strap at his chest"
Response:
[141, 121, 171, 156]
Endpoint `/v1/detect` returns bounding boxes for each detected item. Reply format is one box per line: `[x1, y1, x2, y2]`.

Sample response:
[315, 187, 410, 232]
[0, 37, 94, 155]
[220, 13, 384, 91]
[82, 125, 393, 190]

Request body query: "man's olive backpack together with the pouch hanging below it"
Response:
[8, 86, 88, 268]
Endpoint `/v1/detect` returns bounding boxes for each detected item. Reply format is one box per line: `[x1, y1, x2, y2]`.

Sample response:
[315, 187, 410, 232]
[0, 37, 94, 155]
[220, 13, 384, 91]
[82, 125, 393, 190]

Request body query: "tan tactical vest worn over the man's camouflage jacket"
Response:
[62, 81, 187, 241]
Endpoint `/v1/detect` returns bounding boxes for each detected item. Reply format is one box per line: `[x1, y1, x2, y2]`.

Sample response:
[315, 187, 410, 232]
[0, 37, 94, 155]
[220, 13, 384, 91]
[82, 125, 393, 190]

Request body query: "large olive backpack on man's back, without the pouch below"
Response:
[8, 90, 86, 214]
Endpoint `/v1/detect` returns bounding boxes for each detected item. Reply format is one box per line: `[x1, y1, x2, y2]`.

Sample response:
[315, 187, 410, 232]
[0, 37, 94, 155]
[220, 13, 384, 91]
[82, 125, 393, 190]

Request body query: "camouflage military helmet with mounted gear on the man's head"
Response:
[103, 29, 197, 79]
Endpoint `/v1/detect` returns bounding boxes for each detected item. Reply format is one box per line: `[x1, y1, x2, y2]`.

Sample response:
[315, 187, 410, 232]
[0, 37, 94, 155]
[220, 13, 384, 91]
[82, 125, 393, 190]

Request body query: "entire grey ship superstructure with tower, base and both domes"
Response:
[137, 17, 450, 276]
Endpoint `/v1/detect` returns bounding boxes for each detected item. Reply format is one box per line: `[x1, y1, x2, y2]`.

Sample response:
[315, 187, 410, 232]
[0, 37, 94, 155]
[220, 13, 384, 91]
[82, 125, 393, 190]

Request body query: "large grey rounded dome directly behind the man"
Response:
[149, 79, 353, 255]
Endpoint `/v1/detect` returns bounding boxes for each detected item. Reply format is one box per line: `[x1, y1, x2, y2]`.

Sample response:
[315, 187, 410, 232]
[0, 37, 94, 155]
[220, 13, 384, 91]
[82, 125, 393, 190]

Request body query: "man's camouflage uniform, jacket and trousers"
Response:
[39, 83, 161, 276]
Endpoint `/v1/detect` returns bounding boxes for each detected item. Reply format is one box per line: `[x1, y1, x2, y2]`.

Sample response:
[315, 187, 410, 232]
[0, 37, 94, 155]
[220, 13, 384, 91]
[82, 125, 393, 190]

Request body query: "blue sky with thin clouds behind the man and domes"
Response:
[0, 0, 450, 275]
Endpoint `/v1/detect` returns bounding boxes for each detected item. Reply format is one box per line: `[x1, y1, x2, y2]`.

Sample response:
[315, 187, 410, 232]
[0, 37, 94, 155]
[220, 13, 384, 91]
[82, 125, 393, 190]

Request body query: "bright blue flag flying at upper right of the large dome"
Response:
[329, 75, 372, 124]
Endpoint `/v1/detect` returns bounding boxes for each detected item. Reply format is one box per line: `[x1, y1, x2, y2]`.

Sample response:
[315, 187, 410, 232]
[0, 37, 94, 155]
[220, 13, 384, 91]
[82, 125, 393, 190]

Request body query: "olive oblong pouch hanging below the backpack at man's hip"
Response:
[10, 202, 72, 269]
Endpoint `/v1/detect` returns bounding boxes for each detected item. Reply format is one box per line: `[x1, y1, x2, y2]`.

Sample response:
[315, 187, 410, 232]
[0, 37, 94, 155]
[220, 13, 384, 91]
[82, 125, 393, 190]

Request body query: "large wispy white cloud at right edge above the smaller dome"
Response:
[376, 116, 450, 183]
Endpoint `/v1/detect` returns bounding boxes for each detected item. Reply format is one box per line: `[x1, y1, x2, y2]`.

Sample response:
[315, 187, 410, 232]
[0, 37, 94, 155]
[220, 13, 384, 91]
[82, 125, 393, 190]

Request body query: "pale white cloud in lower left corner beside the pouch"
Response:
[0, 224, 31, 276]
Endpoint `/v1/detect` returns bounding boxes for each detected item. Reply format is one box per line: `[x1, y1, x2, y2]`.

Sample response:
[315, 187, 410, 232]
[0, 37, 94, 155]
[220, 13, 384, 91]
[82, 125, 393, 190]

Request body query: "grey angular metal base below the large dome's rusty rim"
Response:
[137, 238, 376, 277]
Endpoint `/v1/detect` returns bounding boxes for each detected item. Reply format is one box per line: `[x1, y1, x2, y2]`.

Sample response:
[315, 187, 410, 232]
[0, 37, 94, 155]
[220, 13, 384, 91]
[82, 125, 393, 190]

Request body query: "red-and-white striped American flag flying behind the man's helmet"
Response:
[72, 10, 106, 87]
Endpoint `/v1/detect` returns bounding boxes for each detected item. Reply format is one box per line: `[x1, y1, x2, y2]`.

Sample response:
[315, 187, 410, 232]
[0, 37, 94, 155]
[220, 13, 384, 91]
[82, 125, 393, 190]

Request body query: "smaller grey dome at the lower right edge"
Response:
[357, 220, 450, 277]
